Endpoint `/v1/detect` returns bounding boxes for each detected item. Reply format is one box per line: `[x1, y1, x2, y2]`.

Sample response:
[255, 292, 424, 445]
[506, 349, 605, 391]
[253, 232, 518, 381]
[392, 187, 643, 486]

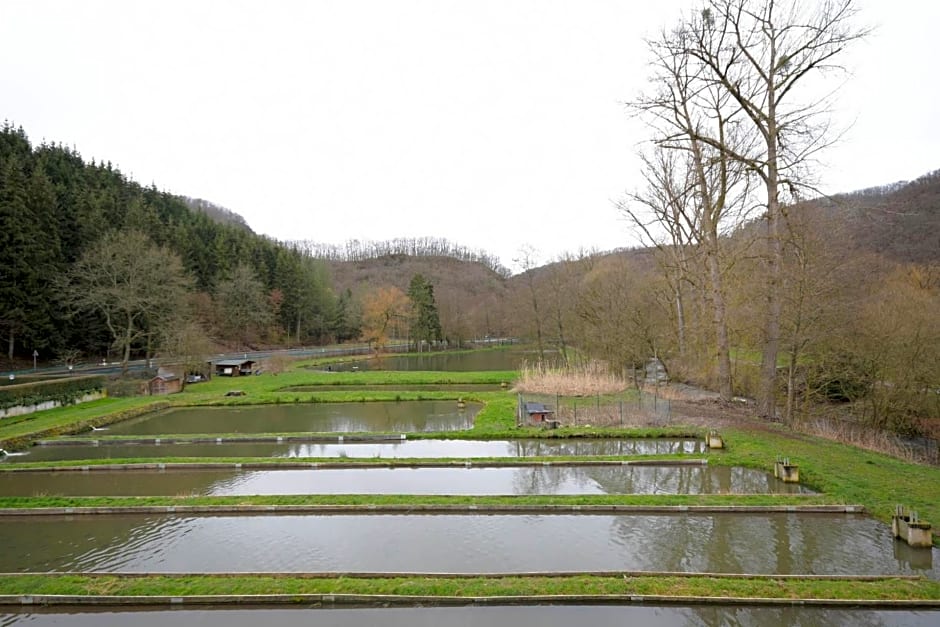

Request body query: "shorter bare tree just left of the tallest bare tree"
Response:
[624, 29, 750, 400]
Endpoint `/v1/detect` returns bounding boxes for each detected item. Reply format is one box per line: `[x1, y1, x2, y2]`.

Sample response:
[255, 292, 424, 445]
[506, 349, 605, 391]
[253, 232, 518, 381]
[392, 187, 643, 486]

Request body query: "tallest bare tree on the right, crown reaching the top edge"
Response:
[640, 0, 866, 418]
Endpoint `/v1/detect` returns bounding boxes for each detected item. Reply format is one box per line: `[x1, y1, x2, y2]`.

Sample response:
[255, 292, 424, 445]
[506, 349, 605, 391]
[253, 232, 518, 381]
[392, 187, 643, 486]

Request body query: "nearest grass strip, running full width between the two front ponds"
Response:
[0, 573, 940, 602]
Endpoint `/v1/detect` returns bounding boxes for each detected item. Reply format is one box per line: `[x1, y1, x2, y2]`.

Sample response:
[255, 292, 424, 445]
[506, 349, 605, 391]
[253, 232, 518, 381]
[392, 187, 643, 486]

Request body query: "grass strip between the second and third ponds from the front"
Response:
[0, 494, 847, 509]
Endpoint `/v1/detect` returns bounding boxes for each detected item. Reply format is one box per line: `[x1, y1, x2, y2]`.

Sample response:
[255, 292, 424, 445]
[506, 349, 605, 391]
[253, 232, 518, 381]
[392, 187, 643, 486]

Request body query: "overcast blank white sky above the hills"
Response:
[0, 0, 940, 266]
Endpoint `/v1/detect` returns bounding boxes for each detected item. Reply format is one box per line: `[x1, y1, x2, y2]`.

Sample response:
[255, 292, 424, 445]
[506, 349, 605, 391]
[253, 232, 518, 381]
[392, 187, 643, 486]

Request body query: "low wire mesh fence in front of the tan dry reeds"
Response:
[516, 390, 672, 427]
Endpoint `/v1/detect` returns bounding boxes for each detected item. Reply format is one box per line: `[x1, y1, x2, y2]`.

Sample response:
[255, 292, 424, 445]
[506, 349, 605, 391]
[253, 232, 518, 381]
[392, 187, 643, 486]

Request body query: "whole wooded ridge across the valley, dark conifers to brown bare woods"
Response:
[0, 124, 940, 431]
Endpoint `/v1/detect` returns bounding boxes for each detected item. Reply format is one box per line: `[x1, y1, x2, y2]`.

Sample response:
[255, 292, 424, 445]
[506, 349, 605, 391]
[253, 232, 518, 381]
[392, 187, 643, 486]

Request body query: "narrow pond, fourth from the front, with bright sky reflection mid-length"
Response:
[11, 440, 707, 463]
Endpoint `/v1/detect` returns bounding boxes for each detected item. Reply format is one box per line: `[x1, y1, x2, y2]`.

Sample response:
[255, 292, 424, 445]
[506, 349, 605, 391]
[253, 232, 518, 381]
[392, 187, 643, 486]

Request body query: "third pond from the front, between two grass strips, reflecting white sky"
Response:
[0, 464, 809, 496]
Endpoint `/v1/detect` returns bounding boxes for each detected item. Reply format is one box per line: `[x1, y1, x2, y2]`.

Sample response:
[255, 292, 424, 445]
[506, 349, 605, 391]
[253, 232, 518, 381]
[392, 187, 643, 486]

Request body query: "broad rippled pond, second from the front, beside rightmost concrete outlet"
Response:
[0, 513, 940, 579]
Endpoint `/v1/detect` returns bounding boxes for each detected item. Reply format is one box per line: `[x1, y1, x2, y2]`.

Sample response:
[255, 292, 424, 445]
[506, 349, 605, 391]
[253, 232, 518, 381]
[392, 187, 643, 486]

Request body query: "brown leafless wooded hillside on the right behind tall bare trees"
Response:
[508, 172, 940, 433]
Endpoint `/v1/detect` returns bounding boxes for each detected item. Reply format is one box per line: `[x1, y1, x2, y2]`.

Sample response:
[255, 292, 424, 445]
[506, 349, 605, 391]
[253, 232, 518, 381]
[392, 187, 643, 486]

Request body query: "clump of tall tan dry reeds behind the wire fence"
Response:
[515, 361, 628, 396]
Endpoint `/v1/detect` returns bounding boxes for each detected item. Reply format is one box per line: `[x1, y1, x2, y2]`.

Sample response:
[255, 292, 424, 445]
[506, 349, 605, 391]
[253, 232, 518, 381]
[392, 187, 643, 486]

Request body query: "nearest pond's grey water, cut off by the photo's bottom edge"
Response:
[0, 605, 940, 627]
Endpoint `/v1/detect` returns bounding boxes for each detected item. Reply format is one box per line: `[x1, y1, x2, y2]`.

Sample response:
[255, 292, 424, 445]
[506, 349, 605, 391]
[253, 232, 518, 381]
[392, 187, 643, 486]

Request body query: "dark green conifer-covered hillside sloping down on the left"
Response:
[0, 124, 348, 368]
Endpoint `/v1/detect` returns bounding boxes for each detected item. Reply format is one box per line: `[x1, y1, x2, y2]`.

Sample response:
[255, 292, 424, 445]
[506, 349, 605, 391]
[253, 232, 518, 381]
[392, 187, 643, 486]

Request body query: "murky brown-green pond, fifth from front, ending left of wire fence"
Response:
[101, 401, 483, 436]
